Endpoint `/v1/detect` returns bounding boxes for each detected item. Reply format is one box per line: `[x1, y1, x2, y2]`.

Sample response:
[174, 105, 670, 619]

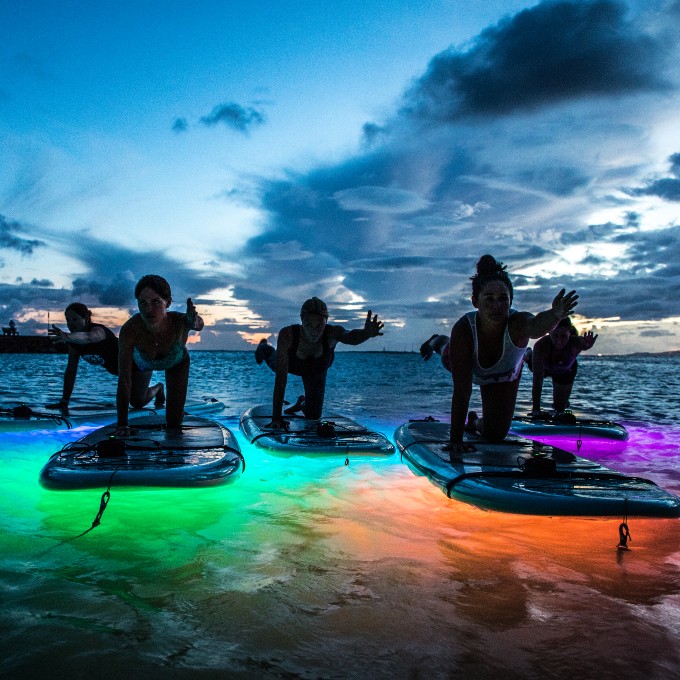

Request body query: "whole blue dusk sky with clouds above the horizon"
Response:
[0, 0, 680, 354]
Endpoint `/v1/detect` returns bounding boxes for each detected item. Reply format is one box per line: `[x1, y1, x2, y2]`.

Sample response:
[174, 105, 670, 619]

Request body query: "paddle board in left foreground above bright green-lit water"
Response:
[40, 416, 245, 490]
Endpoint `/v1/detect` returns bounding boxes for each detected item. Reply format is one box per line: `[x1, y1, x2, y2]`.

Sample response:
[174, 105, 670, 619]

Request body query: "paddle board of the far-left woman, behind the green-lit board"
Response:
[0, 397, 224, 432]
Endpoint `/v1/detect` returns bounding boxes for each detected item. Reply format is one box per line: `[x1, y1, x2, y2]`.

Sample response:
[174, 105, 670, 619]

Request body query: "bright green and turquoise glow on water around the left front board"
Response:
[0, 424, 398, 599]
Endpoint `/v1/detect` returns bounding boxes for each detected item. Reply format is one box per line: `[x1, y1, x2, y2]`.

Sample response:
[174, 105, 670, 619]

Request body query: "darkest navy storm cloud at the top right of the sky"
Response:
[404, 0, 670, 121]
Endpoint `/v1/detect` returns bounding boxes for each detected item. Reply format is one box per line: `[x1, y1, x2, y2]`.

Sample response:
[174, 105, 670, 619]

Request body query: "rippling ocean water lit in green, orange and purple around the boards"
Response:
[0, 351, 680, 680]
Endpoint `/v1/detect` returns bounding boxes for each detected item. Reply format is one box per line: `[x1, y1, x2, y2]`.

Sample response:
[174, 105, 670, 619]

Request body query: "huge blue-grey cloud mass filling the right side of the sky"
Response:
[228, 1, 680, 350]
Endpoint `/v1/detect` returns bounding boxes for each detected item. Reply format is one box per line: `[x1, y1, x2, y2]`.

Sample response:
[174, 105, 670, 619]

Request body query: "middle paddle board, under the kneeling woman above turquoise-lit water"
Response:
[240, 406, 395, 456]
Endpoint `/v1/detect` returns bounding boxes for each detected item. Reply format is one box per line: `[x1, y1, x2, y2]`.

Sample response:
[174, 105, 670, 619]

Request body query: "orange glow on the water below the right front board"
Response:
[320, 460, 680, 599]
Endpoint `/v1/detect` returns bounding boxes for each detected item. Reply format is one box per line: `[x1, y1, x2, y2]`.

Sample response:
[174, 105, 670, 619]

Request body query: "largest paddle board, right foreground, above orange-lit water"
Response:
[394, 421, 680, 517]
